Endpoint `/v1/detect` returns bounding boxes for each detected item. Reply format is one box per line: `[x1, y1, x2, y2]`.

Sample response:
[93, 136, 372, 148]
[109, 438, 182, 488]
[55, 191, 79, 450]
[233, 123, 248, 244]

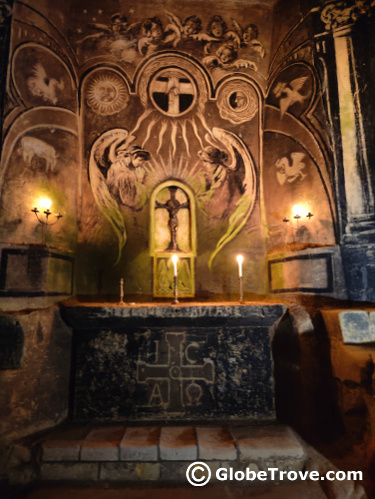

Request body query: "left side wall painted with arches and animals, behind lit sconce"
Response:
[0, 2, 80, 251]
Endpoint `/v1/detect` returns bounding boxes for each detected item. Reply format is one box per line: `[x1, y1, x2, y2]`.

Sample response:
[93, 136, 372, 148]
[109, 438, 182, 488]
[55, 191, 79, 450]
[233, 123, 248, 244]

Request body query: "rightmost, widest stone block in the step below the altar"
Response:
[230, 425, 304, 461]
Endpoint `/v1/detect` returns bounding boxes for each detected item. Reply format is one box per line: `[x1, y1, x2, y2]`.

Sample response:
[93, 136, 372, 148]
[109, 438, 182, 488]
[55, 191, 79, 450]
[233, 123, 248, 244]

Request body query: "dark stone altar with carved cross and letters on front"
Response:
[63, 304, 285, 421]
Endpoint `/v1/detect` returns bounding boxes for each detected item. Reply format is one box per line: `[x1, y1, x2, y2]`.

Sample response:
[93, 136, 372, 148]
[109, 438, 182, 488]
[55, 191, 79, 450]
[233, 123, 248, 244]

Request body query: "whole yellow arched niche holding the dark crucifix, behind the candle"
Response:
[150, 180, 197, 298]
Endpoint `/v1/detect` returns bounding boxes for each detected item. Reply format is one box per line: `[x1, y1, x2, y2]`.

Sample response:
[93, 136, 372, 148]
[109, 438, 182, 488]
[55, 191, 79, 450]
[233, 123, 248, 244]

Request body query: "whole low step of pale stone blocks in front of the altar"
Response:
[41, 425, 305, 479]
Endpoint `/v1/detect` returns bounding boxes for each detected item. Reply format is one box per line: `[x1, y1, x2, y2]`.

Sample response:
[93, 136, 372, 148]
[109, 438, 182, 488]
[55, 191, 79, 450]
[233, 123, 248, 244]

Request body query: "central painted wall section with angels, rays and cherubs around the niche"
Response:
[70, 0, 266, 294]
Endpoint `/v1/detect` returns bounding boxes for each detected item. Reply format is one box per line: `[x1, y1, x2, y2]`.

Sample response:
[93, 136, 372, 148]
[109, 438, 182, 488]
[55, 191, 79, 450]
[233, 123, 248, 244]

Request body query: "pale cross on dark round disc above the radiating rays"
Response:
[151, 73, 195, 116]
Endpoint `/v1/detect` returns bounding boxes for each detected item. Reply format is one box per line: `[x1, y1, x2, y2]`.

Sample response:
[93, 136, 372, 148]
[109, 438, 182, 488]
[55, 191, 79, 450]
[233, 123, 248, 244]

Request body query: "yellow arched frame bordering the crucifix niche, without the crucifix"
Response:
[149, 180, 197, 298]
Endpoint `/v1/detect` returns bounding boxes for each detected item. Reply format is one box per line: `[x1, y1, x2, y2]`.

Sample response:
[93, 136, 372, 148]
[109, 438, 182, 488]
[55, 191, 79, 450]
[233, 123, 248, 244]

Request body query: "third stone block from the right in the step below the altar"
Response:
[160, 426, 198, 461]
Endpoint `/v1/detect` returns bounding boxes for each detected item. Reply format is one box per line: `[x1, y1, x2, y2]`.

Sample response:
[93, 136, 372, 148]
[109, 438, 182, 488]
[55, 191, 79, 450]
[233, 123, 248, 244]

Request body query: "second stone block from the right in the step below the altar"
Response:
[196, 427, 237, 461]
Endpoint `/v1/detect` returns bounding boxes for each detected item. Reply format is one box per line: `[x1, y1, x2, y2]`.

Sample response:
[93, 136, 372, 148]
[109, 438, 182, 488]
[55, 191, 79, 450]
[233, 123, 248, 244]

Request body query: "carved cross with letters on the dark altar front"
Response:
[137, 333, 215, 412]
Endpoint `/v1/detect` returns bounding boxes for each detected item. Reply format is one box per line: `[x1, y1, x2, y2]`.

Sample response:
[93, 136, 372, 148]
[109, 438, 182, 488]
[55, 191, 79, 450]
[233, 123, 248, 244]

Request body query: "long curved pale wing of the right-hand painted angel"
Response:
[208, 128, 256, 270]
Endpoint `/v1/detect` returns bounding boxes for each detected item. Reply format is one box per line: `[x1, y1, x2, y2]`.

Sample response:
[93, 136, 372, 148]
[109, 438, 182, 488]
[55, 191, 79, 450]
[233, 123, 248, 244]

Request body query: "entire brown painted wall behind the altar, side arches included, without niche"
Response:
[2, 1, 338, 295]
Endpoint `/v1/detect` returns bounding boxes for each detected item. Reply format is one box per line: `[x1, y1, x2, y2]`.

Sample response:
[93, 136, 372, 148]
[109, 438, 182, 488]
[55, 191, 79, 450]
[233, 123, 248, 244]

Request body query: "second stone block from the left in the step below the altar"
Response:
[81, 426, 125, 461]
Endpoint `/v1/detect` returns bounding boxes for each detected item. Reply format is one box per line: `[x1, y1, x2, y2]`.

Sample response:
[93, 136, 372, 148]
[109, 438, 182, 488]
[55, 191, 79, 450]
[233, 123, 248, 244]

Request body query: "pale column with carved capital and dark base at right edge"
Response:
[315, 0, 375, 300]
